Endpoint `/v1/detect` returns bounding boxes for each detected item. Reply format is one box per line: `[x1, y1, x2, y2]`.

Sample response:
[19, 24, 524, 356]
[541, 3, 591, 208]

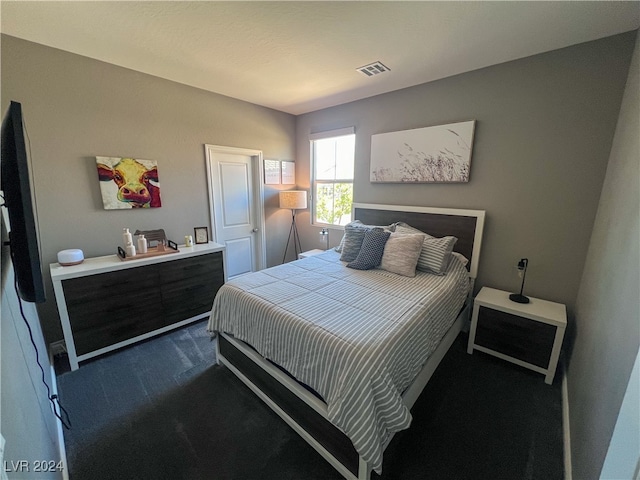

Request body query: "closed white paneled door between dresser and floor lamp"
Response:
[206, 145, 266, 278]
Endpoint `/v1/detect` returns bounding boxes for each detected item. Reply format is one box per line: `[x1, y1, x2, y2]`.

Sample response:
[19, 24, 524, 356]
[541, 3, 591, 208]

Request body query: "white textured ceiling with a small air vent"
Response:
[0, 1, 640, 114]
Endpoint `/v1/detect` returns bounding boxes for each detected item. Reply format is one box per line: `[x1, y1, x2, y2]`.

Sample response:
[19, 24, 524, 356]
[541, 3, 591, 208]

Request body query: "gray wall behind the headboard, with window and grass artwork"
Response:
[296, 33, 634, 318]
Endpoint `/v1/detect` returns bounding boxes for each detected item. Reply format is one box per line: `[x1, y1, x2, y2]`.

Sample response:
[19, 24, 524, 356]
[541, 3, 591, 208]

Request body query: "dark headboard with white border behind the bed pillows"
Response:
[353, 203, 485, 278]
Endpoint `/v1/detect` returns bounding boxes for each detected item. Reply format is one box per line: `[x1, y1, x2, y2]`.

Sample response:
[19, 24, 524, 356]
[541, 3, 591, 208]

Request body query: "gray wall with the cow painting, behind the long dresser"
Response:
[1, 35, 295, 341]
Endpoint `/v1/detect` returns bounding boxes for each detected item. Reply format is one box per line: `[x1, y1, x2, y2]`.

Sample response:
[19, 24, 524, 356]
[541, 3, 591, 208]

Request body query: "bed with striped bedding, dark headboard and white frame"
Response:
[208, 204, 484, 480]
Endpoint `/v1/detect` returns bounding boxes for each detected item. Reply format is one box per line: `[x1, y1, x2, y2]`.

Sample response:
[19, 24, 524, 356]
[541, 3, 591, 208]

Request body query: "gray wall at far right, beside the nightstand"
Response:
[567, 31, 640, 480]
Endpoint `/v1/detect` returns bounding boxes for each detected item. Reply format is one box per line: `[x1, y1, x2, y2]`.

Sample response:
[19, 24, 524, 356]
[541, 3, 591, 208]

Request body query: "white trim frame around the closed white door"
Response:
[204, 144, 267, 270]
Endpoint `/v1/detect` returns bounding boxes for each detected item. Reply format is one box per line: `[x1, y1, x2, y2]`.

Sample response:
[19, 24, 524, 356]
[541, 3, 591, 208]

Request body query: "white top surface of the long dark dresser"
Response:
[49, 242, 226, 282]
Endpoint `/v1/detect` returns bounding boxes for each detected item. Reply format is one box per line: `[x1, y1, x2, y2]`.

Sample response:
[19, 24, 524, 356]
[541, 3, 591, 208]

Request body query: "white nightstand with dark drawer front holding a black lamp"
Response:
[467, 287, 567, 385]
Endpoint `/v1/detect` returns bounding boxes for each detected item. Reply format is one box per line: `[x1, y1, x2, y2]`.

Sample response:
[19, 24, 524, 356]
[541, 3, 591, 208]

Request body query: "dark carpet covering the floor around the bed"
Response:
[57, 322, 563, 480]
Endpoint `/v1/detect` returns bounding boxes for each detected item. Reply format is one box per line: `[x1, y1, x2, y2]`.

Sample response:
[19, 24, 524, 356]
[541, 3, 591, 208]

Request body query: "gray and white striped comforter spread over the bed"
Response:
[208, 251, 469, 473]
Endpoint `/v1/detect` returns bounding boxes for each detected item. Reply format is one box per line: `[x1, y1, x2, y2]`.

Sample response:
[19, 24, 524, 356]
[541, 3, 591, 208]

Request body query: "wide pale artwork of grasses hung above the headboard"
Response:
[370, 120, 476, 183]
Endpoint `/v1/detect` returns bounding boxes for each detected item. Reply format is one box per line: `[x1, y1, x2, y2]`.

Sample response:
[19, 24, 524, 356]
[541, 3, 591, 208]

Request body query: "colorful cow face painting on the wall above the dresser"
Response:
[96, 157, 162, 210]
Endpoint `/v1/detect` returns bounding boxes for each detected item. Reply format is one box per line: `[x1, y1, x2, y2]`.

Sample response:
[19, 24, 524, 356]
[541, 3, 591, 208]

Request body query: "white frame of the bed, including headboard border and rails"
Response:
[216, 203, 485, 480]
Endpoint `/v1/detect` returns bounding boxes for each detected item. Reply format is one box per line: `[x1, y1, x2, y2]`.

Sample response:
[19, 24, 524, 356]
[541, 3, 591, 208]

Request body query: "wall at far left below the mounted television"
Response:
[0, 222, 62, 479]
